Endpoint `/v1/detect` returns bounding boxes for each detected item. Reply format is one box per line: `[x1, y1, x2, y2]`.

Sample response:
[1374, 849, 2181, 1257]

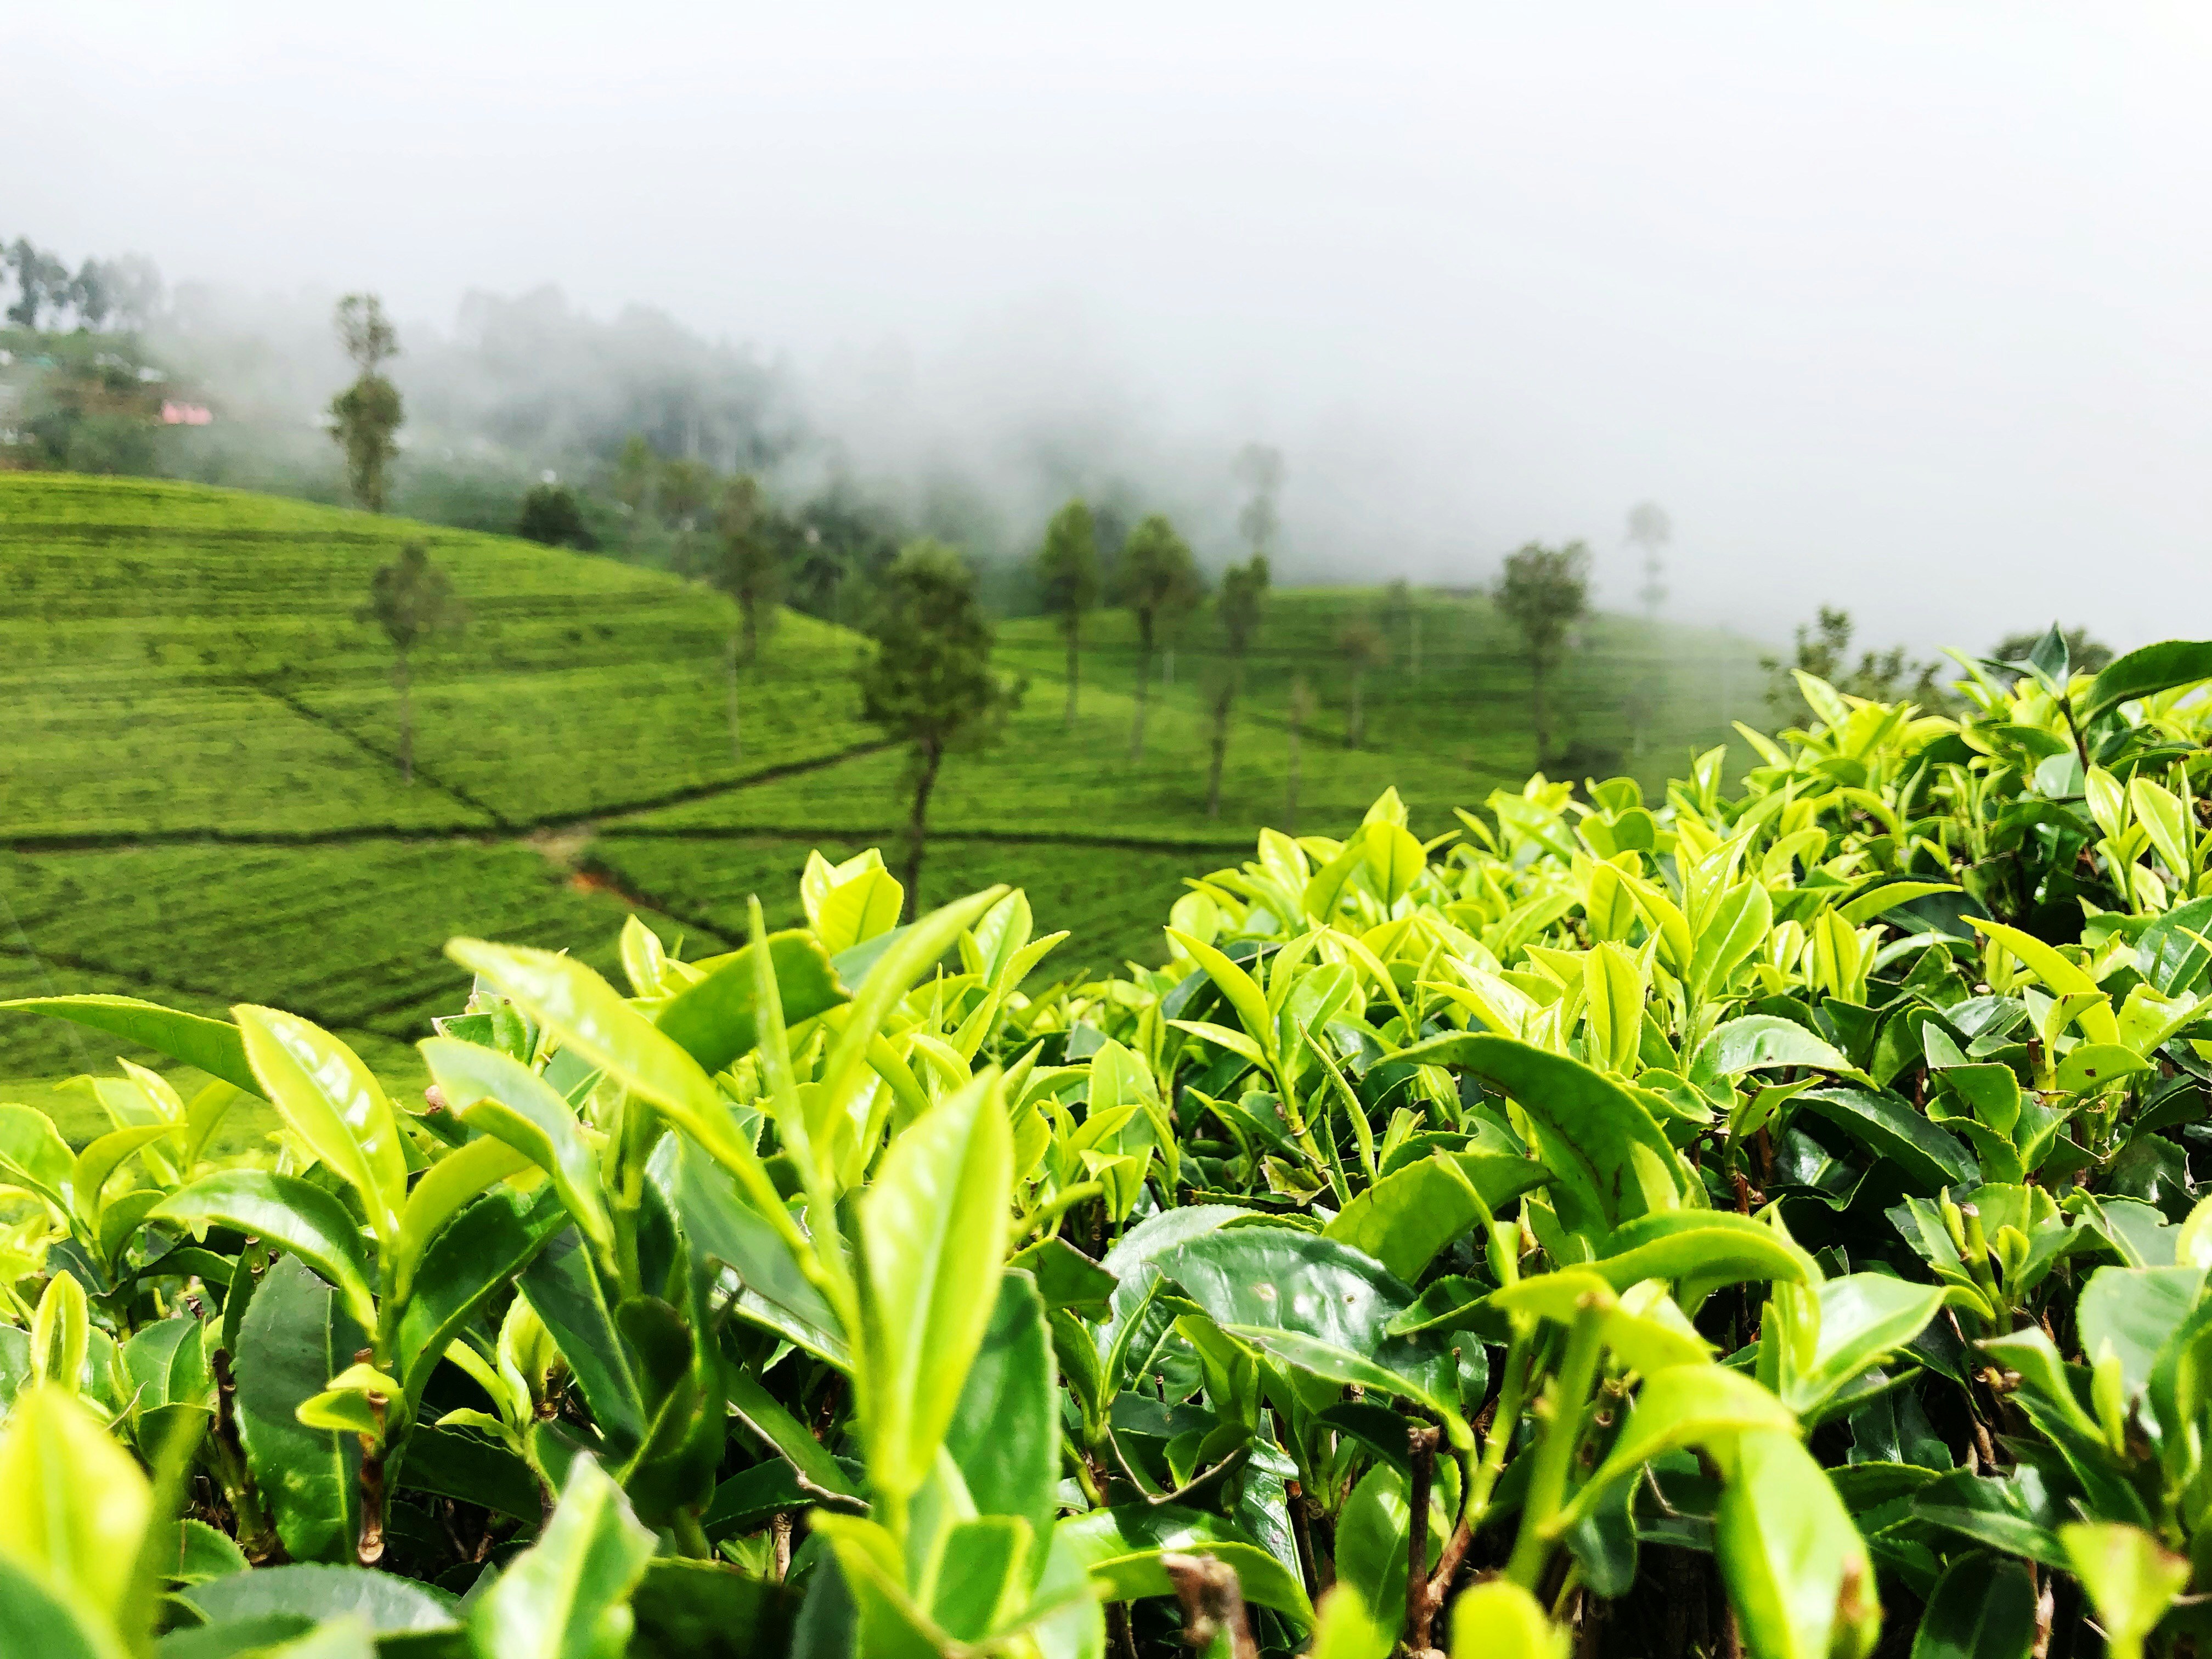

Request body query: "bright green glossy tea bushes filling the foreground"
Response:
[0, 635, 2212, 1659]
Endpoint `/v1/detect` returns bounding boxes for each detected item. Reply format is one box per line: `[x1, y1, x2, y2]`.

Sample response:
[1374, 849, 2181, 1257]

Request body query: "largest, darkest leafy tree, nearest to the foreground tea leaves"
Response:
[860, 538, 1020, 918]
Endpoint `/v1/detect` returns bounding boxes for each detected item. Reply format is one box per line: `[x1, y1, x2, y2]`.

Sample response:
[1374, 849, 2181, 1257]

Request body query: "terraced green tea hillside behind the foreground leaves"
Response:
[0, 473, 1758, 1132]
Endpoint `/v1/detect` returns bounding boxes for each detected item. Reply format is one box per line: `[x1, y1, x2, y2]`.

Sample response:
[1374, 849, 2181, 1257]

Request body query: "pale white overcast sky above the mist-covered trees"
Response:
[0, 0, 2212, 648]
